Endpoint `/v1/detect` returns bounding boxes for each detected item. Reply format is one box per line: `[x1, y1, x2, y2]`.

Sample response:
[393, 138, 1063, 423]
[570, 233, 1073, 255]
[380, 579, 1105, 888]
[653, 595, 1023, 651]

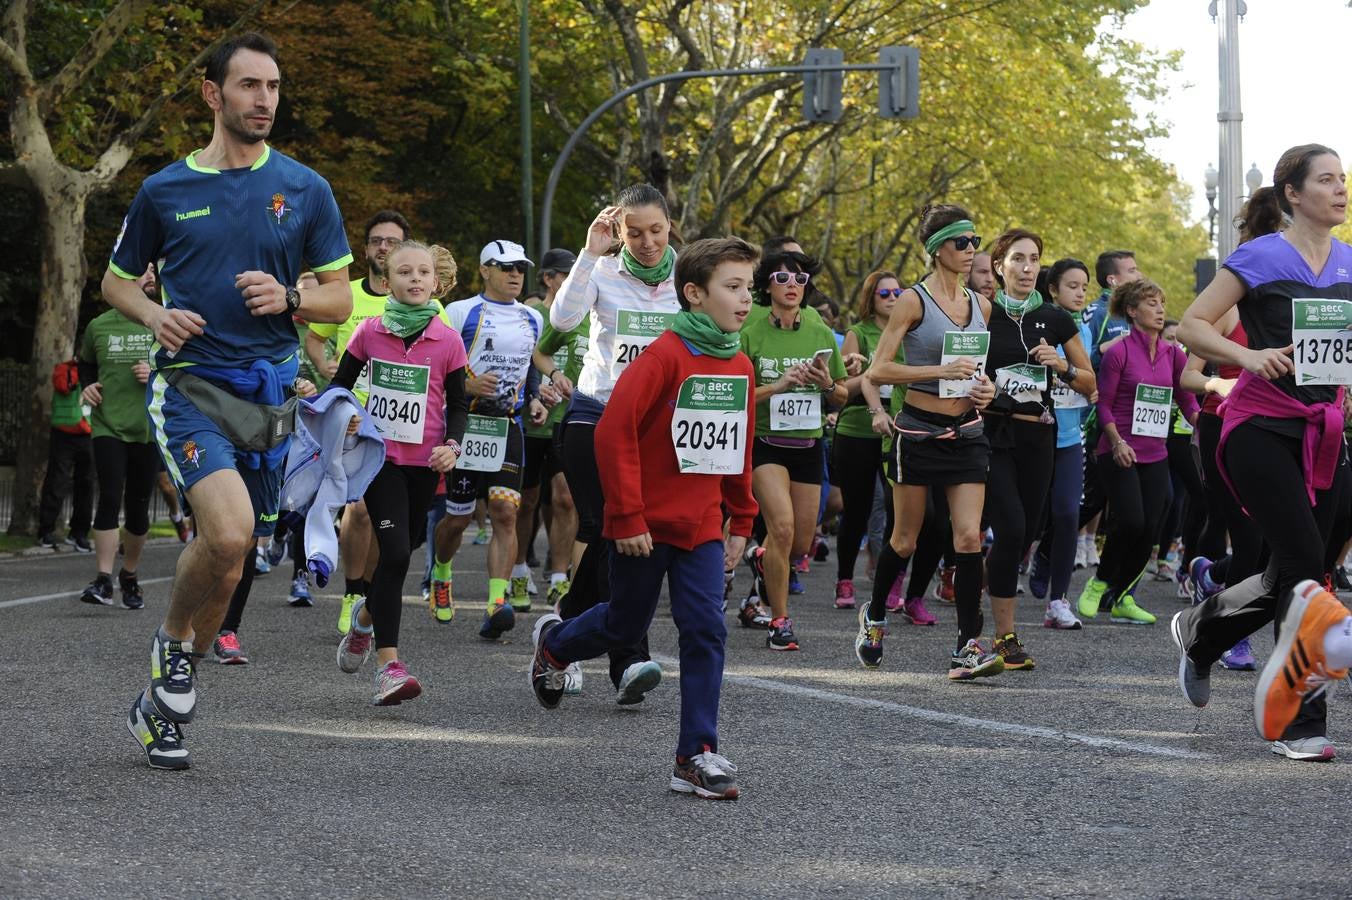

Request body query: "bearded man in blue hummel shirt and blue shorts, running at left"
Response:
[103, 34, 352, 769]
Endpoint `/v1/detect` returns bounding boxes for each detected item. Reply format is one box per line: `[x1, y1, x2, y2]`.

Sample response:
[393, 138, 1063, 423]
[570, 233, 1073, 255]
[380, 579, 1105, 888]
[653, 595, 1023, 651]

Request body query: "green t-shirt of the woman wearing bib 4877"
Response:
[742, 307, 845, 438]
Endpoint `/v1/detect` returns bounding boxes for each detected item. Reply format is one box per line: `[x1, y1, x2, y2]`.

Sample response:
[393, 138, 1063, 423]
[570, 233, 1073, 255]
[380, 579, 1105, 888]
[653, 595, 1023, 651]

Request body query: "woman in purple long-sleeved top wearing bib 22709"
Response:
[1079, 278, 1198, 624]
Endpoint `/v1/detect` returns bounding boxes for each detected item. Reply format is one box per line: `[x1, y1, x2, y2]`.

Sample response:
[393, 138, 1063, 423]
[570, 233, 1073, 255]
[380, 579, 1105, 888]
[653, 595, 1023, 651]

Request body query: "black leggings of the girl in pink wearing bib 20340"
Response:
[365, 462, 437, 649]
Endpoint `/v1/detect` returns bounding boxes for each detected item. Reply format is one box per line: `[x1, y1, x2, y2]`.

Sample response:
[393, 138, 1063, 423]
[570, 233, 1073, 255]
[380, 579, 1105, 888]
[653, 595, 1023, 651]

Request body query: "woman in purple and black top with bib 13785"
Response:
[1172, 145, 1352, 759]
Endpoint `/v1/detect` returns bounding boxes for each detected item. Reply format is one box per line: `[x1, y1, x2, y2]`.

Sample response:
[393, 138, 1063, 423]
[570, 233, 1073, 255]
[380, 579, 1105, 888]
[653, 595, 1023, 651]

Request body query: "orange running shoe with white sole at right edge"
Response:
[1253, 580, 1348, 741]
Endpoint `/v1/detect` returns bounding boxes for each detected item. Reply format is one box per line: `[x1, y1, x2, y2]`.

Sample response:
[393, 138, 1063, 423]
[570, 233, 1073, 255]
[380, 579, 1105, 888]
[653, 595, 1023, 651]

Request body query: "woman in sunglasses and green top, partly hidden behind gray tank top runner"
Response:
[831, 272, 934, 624]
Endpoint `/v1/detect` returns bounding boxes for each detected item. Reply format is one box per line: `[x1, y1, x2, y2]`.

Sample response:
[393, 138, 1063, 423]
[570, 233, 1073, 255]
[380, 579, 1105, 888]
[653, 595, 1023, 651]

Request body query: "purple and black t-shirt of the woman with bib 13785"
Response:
[1225, 234, 1352, 410]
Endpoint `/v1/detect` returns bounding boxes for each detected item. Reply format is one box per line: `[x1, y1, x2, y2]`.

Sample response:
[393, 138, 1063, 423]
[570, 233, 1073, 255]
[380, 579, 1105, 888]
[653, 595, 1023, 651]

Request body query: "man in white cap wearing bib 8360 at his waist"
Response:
[431, 241, 548, 629]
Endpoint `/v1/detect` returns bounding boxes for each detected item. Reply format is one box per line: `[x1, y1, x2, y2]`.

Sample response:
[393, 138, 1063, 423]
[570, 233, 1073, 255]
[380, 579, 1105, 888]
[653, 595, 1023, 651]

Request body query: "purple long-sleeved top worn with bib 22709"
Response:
[1095, 328, 1199, 462]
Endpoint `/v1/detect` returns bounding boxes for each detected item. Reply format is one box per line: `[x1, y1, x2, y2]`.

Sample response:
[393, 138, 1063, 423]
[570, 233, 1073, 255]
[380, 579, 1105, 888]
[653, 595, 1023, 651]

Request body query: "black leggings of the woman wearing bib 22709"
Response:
[1098, 455, 1174, 599]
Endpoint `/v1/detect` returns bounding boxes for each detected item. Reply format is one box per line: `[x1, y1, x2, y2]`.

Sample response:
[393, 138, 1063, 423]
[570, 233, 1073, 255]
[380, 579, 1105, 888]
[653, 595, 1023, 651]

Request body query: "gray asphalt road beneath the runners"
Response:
[0, 543, 1352, 897]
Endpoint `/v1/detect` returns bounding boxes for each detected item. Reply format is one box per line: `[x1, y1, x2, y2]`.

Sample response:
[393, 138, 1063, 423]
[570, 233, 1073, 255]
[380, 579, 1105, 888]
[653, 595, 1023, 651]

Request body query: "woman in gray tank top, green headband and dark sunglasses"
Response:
[854, 205, 1005, 681]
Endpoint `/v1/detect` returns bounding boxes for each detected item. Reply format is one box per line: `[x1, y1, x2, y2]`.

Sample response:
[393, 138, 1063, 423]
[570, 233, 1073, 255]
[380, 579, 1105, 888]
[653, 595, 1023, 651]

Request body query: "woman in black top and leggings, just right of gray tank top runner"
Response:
[986, 228, 1095, 669]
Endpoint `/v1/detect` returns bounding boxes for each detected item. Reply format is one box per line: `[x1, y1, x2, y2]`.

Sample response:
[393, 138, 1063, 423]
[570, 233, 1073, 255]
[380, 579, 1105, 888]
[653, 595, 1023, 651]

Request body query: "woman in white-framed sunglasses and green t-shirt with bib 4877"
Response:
[742, 250, 846, 650]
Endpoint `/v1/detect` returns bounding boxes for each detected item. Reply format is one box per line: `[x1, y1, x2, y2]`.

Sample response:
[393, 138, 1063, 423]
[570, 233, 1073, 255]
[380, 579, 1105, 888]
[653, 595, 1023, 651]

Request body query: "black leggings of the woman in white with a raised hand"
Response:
[558, 422, 650, 686]
